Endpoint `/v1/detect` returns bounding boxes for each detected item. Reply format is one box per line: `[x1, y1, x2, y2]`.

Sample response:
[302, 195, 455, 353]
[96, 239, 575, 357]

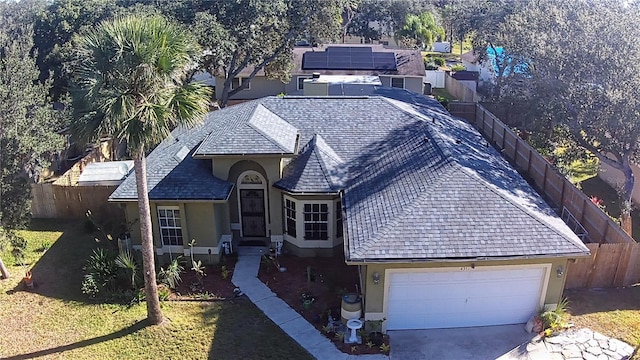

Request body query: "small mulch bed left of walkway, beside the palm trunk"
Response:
[169, 255, 238, 301]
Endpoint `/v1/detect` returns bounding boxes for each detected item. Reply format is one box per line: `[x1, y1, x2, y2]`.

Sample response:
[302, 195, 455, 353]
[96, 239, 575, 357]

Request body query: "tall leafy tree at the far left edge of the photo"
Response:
[0, 3, 66, 229]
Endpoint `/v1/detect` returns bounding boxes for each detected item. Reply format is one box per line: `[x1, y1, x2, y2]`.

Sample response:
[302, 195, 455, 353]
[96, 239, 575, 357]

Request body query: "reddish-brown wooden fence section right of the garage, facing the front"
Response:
[565, 243, 640, 289]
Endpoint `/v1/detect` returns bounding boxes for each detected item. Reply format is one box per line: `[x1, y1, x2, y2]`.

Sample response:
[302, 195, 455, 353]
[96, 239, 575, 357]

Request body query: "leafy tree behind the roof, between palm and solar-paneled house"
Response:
[182, 0, 348, 106]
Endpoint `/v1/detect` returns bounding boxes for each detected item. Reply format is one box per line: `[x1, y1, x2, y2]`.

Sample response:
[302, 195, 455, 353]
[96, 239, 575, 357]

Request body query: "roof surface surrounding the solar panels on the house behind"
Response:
[238, 44, 424, 77]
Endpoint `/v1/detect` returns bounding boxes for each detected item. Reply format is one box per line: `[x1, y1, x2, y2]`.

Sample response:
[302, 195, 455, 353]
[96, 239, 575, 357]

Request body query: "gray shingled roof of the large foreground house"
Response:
[111, 88, 588, 262]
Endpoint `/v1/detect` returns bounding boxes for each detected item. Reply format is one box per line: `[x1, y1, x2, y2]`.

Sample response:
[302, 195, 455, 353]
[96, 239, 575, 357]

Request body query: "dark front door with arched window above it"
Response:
[236, 170, 267, 238]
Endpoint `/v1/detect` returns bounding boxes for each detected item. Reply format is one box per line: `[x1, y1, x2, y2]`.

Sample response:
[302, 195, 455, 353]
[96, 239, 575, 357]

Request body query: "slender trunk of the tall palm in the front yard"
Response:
[133, 153, 164, 325]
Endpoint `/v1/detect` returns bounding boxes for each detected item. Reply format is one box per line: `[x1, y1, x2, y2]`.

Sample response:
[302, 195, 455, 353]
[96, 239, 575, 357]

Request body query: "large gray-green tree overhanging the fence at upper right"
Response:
[464, 0, 640, 229]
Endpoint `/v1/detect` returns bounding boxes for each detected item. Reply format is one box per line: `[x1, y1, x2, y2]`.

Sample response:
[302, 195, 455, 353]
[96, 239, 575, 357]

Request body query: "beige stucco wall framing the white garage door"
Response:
[361, 258, 567, 330]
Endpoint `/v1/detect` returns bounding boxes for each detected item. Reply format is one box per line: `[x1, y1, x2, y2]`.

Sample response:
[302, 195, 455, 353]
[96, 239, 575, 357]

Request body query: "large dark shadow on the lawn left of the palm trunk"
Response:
[7, 220, 98, 302]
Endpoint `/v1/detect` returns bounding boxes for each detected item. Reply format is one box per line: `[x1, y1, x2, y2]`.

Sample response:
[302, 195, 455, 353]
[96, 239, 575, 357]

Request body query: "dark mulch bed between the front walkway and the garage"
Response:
[258, 255, 389, 355]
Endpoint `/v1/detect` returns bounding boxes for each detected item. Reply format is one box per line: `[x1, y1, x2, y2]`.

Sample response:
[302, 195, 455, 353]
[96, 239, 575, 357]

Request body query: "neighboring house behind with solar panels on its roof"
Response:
[216, 44, 424, 100]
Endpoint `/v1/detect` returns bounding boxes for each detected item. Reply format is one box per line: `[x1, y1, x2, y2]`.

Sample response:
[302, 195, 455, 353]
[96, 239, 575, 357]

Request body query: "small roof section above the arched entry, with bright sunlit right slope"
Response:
[196, 104, 298, 156]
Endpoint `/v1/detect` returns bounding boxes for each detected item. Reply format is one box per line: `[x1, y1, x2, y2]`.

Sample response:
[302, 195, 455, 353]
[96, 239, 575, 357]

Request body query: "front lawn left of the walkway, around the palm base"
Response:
[0, 221, 311, 359]
